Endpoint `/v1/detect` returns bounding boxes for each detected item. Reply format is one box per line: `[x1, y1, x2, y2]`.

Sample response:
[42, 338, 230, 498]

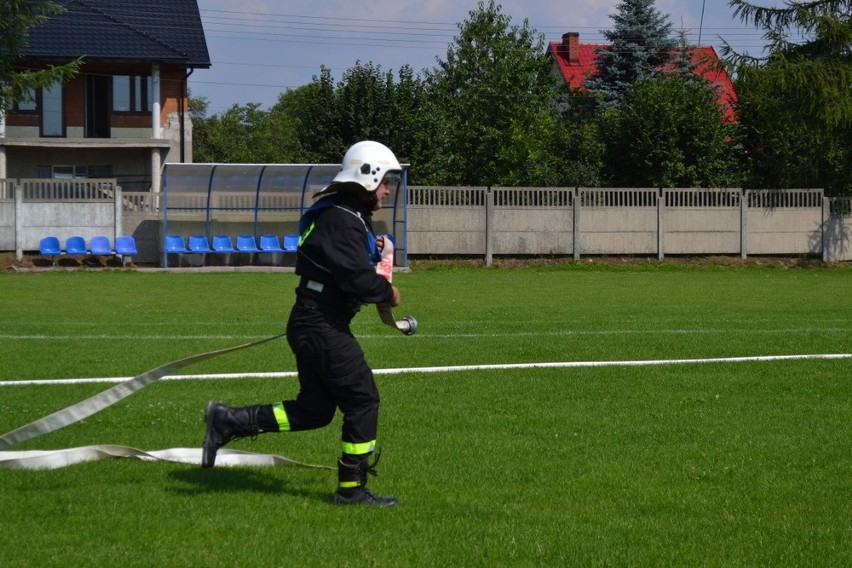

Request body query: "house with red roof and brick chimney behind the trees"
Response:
[546, 32, 737, 122]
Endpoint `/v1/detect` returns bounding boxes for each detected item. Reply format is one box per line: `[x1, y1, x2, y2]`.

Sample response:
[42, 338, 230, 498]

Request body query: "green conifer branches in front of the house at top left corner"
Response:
[0, 0, 82, 112]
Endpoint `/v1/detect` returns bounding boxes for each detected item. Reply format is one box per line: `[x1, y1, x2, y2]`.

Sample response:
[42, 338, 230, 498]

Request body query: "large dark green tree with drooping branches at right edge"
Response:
[722, 0, 852, 195]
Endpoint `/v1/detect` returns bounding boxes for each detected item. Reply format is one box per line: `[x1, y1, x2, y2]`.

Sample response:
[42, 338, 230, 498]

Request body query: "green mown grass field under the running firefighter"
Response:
[0, 262, 852, 567]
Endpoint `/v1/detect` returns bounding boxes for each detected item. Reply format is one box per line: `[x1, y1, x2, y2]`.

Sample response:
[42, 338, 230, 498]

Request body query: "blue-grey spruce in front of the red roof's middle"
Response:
[585, 0, 675, 105]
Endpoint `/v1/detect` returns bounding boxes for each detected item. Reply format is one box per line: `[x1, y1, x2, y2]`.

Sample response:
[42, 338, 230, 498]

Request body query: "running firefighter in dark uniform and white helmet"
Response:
[202, 141, 402, 506]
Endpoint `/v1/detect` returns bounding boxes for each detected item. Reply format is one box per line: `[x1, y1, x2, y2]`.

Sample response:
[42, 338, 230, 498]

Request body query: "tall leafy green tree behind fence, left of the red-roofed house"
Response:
[421, 0, 556, 185]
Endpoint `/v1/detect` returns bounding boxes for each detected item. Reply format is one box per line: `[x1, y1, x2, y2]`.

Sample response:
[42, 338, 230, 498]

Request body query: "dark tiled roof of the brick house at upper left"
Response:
[21, 0, 210, 68]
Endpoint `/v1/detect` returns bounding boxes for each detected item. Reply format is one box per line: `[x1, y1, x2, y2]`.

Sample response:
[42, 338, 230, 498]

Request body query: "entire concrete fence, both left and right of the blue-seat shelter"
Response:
[0, 179, 852, 263]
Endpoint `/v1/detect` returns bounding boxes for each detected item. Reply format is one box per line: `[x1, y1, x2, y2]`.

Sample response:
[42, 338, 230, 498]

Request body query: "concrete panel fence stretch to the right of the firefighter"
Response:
[408, 187, 852, 262]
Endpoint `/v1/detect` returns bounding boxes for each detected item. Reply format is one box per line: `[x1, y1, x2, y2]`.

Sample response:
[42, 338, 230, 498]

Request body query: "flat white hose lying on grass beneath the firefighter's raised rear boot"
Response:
[0, 444, 337, 471]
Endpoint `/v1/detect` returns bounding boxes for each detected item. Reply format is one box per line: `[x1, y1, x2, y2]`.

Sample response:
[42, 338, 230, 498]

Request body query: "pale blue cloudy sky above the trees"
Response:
[189, 0, 764, 115]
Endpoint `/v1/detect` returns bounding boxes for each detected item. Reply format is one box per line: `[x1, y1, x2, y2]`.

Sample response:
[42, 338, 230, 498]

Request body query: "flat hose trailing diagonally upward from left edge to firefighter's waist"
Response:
[0, 333, 285, 450]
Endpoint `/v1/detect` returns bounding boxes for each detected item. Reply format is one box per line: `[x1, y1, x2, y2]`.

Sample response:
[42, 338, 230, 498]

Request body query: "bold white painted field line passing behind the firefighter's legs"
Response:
[0, 353, 852, 387]
